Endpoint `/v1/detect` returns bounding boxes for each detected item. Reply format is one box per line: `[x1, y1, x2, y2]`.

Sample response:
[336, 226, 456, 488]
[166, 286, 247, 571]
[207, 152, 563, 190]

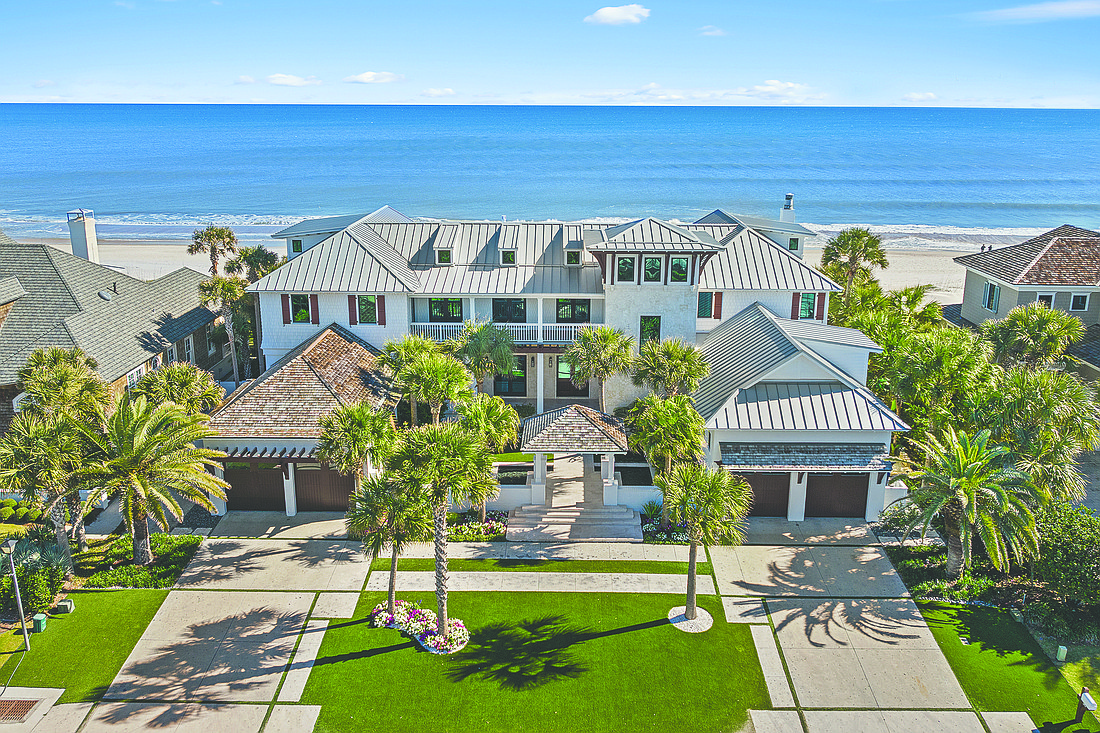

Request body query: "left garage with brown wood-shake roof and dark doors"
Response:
[204, 324, 397, 516]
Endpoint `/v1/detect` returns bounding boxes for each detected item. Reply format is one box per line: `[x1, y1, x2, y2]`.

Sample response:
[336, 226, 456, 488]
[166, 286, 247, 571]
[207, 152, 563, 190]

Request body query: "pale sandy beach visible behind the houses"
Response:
[26, 239, 968, 304]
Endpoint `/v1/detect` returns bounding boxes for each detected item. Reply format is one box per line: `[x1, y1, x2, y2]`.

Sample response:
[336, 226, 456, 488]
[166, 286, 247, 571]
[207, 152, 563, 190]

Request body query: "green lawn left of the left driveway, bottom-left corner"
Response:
[0, 590, 168, 702]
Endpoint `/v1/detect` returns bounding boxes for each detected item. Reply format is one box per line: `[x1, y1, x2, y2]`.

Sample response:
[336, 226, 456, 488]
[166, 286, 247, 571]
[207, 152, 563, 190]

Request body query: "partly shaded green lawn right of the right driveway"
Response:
[917, 601, 1100, 733]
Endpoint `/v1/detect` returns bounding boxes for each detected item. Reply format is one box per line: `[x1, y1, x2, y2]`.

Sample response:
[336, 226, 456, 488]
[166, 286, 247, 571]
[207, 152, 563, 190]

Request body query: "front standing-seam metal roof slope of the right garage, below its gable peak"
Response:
[710, 382, 909, 430]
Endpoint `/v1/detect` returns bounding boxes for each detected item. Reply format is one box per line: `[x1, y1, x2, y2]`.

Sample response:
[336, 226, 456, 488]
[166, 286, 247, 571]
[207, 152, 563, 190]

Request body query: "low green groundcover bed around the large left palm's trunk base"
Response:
[73, 533, 202, 588]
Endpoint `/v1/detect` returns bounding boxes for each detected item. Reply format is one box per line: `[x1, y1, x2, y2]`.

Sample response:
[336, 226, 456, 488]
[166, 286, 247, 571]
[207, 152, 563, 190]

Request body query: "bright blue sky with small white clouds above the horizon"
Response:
[0, 0, 1100, 108]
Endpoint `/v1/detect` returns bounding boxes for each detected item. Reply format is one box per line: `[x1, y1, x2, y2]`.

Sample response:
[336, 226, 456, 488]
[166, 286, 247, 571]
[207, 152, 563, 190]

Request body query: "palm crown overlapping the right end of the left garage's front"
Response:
[317, 401, 397, 490]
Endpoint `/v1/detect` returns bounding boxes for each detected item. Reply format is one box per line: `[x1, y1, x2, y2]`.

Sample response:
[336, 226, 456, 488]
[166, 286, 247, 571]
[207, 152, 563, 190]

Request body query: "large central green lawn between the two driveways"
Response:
[301, 592, 771, 733]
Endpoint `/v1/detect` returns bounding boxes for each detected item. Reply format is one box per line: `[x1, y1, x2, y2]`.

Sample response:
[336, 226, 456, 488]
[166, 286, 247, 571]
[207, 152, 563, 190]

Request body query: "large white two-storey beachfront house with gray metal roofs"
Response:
[211, 197, 906, 519]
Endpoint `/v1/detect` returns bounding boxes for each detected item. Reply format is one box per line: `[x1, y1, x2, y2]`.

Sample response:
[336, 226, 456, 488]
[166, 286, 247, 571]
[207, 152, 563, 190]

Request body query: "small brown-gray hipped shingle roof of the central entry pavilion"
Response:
[519, 405, 629, 453]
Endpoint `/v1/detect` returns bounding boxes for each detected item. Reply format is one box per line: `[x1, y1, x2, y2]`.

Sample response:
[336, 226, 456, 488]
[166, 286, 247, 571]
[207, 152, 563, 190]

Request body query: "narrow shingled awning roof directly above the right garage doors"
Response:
[719, 442, 893, 473]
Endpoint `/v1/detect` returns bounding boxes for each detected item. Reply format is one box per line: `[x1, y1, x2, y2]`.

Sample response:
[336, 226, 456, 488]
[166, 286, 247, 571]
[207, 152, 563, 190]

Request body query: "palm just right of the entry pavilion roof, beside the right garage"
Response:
[630, 394, 703, 528]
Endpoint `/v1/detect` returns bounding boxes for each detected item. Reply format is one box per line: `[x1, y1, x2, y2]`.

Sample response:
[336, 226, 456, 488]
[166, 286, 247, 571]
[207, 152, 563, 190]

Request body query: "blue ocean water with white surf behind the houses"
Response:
[0, 105, 1100, 248]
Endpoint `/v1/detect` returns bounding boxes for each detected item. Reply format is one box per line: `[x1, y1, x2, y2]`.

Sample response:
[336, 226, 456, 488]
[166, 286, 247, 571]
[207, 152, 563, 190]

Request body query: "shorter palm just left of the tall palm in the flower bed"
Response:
[344, 473, 431, 614]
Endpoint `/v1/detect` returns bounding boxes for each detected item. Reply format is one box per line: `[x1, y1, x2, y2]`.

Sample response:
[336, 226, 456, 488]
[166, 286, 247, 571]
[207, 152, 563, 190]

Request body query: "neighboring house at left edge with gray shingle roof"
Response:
[0, 237, 229, 431]
